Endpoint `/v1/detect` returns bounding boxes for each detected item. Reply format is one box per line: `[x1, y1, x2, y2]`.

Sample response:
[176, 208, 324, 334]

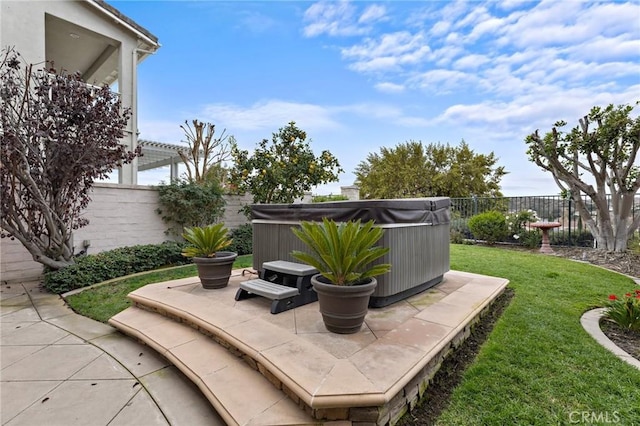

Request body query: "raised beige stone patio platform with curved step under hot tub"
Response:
[110, 271, 508, 425]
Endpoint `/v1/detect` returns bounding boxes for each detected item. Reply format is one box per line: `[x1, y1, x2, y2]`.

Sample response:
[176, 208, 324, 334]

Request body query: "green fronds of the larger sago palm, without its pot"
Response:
[291, 218, 391, 285]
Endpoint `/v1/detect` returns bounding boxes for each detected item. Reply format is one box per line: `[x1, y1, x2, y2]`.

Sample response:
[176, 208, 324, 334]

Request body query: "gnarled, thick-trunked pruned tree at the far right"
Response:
[525, 101, 640, 251]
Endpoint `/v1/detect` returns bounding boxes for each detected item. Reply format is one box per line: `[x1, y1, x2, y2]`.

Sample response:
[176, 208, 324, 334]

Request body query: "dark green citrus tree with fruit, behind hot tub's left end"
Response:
[231, 121, 343, 203]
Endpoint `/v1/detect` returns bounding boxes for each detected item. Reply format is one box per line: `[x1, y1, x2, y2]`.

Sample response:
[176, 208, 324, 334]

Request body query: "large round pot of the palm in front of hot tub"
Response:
[311, 274, 378, 334]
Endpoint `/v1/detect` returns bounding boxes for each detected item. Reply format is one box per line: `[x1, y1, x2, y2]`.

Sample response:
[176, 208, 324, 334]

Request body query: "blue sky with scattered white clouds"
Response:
[109, 0, 640, 196]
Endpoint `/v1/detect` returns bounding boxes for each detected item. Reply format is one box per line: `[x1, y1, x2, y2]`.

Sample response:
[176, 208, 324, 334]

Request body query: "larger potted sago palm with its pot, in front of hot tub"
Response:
[291, 218, 391, 334]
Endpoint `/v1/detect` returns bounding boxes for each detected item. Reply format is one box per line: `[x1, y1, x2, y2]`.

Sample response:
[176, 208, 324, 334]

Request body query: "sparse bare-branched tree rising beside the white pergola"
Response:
[178, 120, 235, 185]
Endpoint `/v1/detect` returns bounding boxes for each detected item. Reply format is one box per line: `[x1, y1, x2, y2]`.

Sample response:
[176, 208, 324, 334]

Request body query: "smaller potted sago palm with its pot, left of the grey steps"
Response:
[182, 223, 238, 289]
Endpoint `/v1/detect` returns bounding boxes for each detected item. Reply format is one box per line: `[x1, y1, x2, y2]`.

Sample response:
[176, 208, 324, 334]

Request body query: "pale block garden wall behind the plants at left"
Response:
[0, 184, 251, 282]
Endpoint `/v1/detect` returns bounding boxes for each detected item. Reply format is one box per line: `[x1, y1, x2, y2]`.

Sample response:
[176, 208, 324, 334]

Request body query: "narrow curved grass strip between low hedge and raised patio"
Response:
[66, 255, 253, 322]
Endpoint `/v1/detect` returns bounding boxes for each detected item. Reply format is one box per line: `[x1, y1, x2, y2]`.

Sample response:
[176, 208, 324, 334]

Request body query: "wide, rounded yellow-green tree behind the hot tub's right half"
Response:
[355, 141, 507, 199]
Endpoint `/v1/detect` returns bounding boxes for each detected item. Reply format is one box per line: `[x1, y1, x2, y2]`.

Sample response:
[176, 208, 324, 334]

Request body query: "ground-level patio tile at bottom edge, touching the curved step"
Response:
[140, 366, 225, 426]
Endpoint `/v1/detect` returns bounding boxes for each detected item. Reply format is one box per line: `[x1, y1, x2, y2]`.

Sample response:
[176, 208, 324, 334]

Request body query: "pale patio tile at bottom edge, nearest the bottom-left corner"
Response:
[7, 380, 140, 426]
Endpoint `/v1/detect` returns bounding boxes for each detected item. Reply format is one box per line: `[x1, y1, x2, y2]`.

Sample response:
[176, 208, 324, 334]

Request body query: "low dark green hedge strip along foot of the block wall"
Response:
[44, 241, 191, 293]
